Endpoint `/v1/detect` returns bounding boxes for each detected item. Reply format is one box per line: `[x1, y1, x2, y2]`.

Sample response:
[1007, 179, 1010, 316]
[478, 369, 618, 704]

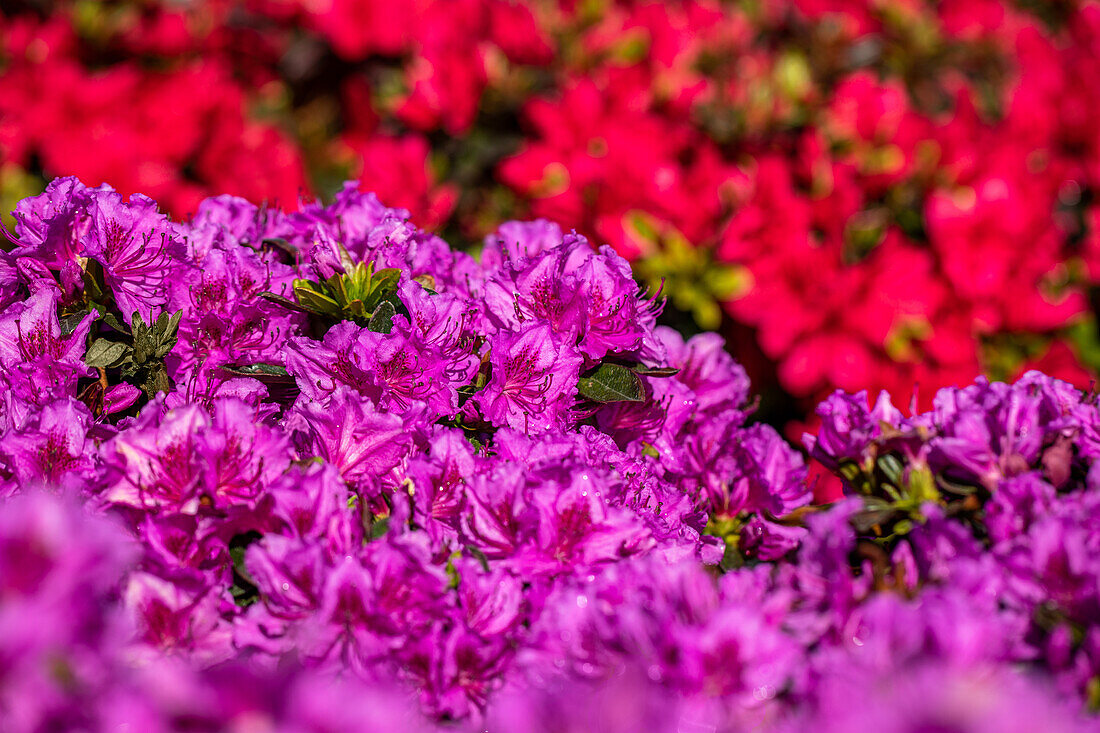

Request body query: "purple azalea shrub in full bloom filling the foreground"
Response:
[0, 178, 1100, 733]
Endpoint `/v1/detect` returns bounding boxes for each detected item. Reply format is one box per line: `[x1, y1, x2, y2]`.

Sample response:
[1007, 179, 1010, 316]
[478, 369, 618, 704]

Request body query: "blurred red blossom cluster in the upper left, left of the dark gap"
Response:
[0, 3, 308, 211]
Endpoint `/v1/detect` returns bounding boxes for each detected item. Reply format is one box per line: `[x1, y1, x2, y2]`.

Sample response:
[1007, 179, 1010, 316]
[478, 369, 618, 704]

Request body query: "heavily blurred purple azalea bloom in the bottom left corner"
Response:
[0, 491, 138, 731]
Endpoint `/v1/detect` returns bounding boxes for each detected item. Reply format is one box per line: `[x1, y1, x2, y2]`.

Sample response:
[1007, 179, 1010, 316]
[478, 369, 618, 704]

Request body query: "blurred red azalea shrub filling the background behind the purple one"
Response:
[0, 0, 1100, 422]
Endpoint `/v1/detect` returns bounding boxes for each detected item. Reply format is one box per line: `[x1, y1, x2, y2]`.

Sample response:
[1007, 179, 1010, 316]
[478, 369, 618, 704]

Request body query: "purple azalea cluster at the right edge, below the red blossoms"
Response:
[802, 372, 1100, 730]
